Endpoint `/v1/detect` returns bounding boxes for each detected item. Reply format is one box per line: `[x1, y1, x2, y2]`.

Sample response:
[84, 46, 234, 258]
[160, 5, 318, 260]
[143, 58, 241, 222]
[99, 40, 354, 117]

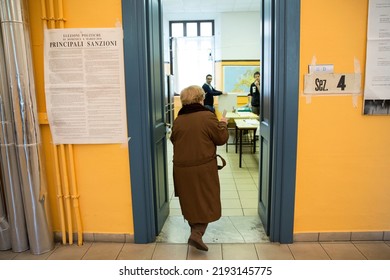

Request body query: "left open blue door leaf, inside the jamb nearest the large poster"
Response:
[147, 0, 169, 235]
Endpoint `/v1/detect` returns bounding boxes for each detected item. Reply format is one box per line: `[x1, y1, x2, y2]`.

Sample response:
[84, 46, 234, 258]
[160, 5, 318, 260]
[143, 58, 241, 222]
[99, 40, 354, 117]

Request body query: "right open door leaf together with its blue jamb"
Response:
[258, 0, 300, 243]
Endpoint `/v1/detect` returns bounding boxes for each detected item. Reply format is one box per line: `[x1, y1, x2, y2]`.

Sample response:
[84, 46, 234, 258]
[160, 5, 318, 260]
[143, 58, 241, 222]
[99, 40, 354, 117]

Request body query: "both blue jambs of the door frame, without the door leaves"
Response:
[122, 0, 300, 243]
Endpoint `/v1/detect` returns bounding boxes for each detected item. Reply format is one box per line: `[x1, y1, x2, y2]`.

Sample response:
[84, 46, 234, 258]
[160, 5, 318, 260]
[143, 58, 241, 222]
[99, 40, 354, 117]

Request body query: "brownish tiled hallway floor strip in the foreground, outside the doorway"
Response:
[0, 241, 390, 260]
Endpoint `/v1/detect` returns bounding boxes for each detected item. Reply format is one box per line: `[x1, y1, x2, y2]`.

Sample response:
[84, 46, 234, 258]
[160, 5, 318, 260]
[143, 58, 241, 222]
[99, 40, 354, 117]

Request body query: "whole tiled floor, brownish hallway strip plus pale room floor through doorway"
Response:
[0, 133, 390, 260]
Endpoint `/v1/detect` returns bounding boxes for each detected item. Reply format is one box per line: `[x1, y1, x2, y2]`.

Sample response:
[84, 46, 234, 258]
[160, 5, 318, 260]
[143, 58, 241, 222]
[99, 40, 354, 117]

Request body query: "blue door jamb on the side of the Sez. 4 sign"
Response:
[270, 0, 300, 243]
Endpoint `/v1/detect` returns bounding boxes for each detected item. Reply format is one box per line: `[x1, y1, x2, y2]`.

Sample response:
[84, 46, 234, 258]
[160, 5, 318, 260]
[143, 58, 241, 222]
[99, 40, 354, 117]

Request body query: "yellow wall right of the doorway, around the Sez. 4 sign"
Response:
[294, 0, 390, 233]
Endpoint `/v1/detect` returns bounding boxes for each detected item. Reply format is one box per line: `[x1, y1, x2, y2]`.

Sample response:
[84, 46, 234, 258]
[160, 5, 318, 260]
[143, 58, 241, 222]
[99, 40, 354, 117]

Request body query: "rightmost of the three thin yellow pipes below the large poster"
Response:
[67, 145, 83, 246]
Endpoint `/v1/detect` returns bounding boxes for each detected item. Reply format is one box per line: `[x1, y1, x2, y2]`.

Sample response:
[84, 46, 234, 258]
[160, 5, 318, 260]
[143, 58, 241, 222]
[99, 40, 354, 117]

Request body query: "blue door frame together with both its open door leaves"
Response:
[122, 0, 299, 243]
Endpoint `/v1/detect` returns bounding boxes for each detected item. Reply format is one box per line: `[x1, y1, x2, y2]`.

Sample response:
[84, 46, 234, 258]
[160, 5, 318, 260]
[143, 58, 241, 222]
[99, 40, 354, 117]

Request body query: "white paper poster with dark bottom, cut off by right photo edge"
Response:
[364, 0, 390, 115]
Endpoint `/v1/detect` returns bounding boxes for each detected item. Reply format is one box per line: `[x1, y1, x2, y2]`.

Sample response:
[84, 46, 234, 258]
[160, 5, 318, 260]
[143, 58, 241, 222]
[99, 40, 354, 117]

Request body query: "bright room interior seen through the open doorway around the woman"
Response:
[156, 0, 269, 243]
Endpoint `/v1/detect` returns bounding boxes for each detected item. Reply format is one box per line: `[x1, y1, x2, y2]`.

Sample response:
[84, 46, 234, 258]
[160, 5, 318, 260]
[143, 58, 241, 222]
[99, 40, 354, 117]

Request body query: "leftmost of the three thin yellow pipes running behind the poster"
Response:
[41, 0, 66, 244]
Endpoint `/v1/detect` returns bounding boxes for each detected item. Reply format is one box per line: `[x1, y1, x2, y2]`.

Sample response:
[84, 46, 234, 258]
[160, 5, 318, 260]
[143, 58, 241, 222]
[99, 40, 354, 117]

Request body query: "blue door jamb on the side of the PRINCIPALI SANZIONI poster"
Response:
[122, 0, 156, 244]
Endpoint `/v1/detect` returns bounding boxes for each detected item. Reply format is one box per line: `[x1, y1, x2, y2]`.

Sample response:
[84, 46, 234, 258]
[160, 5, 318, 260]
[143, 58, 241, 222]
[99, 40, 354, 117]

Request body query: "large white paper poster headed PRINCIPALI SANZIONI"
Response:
[44, 28, 127, 144]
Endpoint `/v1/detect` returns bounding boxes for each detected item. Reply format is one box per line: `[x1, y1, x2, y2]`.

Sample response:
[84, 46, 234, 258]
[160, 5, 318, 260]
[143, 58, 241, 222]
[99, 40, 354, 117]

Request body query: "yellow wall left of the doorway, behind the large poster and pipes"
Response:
[28, 0, 134, 234]
